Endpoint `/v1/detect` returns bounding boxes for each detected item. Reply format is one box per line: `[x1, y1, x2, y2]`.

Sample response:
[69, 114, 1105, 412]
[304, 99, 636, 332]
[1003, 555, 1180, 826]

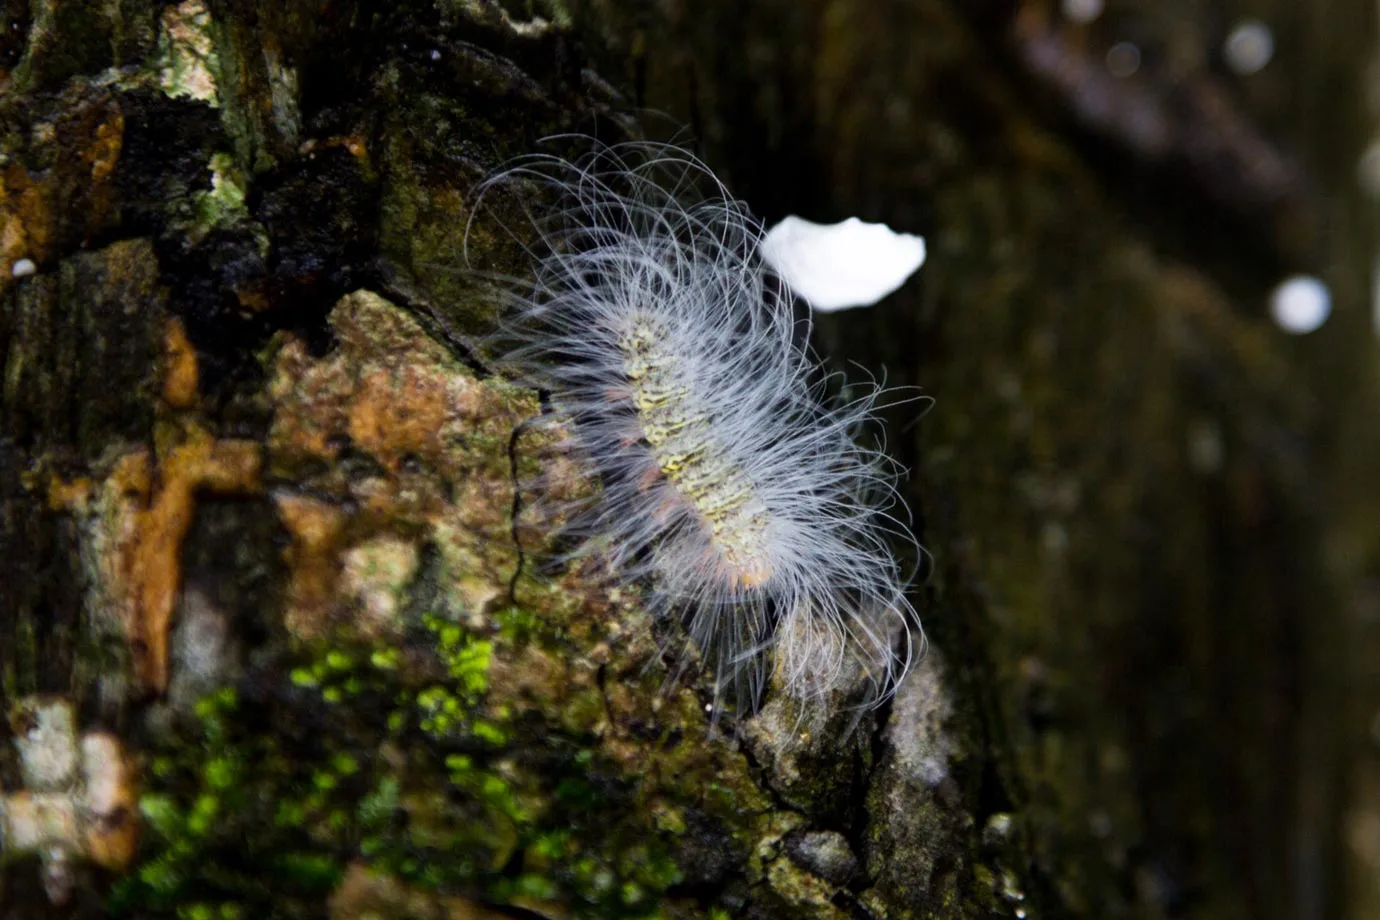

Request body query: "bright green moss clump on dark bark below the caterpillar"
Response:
[112, 598, 741, 917]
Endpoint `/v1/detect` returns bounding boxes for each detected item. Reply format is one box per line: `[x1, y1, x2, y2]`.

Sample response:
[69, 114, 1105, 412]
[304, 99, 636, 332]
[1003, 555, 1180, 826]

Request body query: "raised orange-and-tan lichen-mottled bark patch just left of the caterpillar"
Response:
[260, 291, 538, 639]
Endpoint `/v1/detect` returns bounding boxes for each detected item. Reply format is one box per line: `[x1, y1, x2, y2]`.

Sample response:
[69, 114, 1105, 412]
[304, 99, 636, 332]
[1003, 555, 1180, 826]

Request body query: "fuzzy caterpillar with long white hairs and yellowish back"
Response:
[466, 145, 923, 708]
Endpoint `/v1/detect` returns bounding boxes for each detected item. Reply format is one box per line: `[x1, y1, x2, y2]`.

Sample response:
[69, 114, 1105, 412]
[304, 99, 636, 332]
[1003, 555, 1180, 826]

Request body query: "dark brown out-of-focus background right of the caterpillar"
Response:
[577, 0, 1380, 920]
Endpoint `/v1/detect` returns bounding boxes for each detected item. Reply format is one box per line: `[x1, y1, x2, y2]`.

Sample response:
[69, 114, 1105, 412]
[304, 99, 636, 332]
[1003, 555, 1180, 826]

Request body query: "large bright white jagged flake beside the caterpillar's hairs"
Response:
[762, 215, 925, 313]
